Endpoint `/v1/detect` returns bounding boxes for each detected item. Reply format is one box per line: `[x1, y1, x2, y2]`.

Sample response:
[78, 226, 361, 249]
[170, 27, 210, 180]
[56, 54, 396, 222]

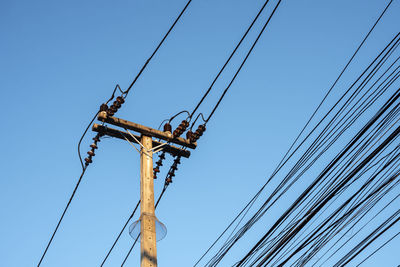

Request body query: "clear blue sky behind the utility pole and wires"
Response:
[0, 0, 400, 267]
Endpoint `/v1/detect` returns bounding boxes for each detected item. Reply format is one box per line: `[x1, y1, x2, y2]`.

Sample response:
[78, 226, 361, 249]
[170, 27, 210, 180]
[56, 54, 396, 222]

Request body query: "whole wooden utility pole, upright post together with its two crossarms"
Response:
[92, 111, 197, 267]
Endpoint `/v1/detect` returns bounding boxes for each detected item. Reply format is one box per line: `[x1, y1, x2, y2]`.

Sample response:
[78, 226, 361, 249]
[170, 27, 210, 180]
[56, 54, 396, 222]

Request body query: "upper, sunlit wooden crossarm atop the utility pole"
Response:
[97, 111, 197, 149]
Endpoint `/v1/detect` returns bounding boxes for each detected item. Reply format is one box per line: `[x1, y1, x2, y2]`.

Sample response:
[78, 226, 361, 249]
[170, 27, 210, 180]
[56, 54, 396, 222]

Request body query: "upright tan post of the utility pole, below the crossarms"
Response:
[140, 134, 157, 267]
